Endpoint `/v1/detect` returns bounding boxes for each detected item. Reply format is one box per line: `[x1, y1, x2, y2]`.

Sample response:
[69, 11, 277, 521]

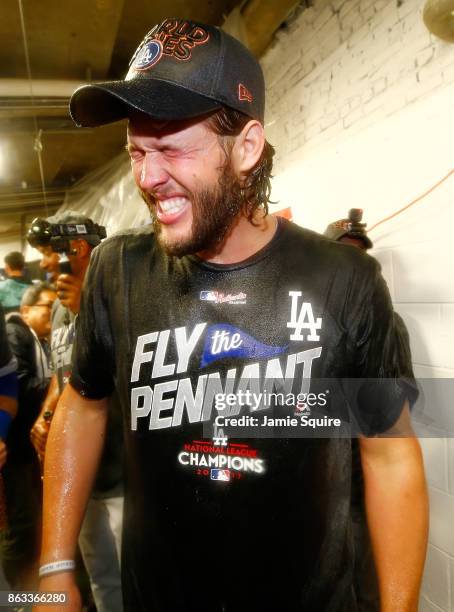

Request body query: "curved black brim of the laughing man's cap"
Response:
[69, 79, 221, 127]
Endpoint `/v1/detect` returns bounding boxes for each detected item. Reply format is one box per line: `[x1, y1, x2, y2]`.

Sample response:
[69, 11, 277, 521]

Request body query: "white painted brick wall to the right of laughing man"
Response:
[262, 0, 454, 612]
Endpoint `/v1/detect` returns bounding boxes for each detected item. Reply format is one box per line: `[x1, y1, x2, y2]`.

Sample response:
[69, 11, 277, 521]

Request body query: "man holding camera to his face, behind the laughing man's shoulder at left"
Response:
[31, 212, 123, 612]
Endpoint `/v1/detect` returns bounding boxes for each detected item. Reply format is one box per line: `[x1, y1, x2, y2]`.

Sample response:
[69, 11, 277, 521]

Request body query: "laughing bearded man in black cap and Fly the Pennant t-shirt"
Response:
[40, 19, 427, 612]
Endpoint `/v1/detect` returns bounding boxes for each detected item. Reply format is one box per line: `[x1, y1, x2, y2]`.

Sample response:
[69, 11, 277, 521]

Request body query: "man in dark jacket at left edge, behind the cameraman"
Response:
[1, 283, 57, 589]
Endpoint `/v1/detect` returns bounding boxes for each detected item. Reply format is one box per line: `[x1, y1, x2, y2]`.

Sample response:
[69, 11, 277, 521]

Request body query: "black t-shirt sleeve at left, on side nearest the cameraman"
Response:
[70, 248, 114, 399]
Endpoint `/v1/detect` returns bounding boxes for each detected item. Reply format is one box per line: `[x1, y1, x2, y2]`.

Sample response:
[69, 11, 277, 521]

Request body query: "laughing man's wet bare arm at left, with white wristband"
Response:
[37, 384, 107, 612]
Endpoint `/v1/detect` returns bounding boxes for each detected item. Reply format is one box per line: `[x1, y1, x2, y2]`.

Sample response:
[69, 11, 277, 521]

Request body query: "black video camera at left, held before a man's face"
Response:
[27, 217, 107, 253]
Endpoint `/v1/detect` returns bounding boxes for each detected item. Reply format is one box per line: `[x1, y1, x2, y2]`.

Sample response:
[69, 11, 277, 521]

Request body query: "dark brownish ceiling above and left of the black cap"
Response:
[0, 0, 298, 249]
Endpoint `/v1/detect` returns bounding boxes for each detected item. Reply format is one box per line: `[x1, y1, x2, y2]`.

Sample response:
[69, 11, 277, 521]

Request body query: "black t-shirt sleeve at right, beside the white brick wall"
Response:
[349, 258, 418, 436]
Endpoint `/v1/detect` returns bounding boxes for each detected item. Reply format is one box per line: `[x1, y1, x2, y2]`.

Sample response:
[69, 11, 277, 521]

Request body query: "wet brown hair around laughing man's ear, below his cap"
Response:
[207, 107, 274, 221]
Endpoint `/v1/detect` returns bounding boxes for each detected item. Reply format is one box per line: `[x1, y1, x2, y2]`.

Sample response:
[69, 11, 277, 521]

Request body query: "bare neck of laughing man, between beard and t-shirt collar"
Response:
[197, 211, 277, 264]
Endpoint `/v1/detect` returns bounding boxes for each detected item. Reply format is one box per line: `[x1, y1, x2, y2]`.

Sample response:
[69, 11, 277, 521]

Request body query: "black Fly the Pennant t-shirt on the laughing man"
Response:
[71, 221, 414, 612]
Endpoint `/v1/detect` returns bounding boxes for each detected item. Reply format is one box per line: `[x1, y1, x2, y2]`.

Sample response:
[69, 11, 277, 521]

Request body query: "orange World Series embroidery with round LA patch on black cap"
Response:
[130, 19, 210, 70]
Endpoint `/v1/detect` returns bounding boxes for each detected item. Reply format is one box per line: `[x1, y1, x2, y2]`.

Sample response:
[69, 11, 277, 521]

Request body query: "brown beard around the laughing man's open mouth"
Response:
[141, 160, 245, 257]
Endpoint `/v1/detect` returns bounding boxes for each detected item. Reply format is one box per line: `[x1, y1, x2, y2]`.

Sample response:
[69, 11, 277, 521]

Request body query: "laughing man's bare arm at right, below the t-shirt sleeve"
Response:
[360, 404, 429, 612]
